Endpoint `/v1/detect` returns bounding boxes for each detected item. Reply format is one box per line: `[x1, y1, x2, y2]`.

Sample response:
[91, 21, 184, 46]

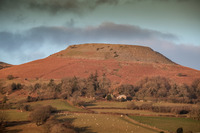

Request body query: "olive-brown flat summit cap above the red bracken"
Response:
[52, 44, 175, 64]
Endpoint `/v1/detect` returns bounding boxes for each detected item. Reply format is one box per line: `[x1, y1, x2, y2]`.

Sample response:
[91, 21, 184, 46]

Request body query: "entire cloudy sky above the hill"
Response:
[0, 0, 200, 70]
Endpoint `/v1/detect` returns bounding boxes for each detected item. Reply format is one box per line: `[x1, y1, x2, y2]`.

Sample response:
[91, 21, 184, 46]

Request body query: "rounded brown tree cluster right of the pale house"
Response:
[115, 77, 200, 103]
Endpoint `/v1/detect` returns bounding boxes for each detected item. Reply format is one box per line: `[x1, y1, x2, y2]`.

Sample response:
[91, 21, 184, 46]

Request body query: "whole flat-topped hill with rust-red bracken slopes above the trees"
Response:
[0, 44, 200, 84]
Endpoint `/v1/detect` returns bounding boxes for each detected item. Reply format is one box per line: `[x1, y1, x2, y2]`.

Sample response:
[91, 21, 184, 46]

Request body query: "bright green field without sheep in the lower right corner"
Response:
[130, 116, 200, 132]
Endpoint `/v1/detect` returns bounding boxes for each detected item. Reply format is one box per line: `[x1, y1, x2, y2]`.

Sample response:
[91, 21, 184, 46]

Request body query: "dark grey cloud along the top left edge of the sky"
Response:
[0, 0, 119, 14]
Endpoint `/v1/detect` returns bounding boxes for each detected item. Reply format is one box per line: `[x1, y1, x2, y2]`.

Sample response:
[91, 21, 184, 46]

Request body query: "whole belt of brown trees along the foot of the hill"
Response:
[1, 72, 200, 103]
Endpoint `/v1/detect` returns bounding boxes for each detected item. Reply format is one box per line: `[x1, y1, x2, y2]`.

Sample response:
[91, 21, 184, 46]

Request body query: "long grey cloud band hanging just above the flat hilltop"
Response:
[0, 22, 177, 50]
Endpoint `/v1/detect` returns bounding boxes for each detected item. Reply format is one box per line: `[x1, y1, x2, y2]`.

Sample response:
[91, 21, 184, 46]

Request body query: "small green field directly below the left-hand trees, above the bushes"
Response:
[27, 99, 83, 111]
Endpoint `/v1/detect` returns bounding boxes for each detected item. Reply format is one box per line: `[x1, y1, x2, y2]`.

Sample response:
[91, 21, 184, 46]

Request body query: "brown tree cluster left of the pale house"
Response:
[27, 72, 111, 102]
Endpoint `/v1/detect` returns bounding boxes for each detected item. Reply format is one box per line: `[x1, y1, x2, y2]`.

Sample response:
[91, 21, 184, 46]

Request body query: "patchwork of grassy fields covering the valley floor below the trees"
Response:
[1, 99, 200, 133]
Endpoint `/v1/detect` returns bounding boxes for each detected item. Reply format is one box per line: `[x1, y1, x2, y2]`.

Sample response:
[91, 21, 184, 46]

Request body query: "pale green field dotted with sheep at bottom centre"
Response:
[59, 113, 156, 133]
